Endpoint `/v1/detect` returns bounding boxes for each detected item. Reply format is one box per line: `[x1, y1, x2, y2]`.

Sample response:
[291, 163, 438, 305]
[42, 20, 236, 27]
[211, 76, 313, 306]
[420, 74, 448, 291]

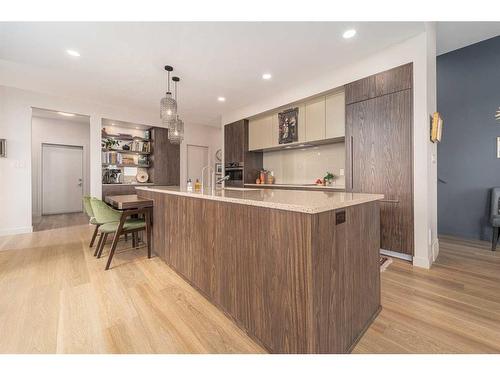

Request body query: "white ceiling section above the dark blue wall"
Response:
[436, 22, 500, 55]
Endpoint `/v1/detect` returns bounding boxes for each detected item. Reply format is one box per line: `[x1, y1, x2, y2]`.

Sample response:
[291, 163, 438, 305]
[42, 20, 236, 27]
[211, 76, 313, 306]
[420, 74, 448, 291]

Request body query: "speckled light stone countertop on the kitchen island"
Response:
[136, 186, 384, 214]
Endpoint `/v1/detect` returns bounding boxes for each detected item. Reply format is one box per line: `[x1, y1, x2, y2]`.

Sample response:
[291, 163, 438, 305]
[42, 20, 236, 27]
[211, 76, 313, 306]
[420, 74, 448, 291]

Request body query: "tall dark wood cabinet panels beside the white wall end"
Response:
[346, 65, 414, 255]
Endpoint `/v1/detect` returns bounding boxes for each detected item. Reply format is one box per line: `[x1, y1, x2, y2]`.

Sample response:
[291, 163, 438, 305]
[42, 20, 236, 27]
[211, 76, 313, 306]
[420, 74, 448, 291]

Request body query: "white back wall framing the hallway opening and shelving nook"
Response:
[0, 85, 221, 235]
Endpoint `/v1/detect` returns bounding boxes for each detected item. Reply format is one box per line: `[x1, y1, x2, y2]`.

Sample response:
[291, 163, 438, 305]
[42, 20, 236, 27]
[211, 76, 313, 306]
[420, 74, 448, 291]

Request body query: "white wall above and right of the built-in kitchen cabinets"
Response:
[222, 28, 438, 268]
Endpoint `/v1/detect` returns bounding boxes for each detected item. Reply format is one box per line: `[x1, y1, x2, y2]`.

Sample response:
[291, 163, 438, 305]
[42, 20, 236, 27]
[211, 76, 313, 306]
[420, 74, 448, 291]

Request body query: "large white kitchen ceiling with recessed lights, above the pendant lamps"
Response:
[0, 22, 496, 126]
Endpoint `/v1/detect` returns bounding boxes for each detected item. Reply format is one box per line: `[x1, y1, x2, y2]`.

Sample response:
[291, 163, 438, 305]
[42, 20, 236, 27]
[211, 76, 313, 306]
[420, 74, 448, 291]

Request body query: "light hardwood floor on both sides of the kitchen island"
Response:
[0, 225, 500, 353]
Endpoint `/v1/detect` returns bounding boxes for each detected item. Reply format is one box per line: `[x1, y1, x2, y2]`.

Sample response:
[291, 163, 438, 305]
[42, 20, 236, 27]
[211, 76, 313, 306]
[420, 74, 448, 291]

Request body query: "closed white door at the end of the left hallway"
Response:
[42, 144, 83, 215]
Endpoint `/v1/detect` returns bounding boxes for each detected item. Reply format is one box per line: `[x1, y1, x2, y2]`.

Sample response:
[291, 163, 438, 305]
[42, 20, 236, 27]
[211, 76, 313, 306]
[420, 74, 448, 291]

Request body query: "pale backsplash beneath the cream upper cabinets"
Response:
[263, 143, 345, 187]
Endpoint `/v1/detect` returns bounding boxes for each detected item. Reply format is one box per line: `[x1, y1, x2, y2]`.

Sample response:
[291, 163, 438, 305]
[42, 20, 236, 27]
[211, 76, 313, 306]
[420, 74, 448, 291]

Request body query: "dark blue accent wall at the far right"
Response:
[437, 36, 500, 240]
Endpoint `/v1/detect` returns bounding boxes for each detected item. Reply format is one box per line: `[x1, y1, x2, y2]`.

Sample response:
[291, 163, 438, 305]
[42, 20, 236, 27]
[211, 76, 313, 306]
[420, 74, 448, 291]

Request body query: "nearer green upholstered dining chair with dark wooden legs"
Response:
[90, 198, 151, 270]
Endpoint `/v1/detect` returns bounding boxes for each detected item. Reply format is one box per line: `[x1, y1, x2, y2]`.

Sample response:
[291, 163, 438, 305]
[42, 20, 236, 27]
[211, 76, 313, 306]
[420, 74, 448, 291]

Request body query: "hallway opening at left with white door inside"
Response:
[31, 108, 90, 231]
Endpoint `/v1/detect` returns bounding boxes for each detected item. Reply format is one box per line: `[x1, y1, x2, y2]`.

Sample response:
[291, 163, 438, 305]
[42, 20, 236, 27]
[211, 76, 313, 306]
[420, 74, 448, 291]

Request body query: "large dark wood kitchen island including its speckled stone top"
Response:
[137, 186, 383, 353]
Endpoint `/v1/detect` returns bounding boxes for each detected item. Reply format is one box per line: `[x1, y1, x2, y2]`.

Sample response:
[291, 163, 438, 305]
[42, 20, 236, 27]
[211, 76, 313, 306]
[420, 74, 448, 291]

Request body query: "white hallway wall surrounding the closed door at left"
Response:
[31, 117, 90, 216]
